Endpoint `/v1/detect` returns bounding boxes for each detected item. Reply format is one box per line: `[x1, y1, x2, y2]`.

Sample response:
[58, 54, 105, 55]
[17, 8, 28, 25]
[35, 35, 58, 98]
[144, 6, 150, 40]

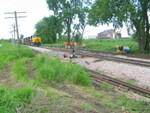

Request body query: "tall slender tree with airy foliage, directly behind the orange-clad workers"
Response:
[46, 0, 89, 42]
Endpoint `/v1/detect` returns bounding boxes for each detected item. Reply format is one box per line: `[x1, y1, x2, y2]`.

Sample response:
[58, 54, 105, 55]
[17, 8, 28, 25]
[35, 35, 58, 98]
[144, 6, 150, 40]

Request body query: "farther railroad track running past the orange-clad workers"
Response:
[40, 47, 150, 67]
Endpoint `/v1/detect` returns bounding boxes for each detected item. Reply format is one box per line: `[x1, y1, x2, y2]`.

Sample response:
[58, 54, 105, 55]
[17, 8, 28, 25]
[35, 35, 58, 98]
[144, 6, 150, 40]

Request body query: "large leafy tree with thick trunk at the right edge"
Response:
[89, 0, 150, 51]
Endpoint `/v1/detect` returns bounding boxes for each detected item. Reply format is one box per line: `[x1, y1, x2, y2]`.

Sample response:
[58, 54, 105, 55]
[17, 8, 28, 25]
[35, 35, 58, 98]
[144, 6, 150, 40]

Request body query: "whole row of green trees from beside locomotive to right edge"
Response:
[35, 0, 150, 51]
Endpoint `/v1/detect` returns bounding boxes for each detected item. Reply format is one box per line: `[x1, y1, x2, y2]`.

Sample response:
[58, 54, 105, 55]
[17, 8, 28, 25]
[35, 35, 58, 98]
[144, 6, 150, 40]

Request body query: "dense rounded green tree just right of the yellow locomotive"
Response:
[35, 16, 63, 43]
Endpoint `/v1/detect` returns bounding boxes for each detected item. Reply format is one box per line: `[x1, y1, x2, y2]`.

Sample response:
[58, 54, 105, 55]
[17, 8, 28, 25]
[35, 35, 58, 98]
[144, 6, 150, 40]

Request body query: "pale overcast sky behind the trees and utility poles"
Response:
[0, 0, 128, 39]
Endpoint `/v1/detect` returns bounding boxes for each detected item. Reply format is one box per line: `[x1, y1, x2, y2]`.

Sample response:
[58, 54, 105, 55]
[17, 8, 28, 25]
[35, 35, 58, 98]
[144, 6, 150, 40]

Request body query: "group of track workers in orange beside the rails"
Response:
[64, 42, 86, 49]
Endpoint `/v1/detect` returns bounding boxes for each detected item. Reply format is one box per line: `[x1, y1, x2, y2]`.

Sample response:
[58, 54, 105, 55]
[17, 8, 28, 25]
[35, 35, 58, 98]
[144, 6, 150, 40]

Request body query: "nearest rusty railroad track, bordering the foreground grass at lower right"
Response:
[87, 70, 150, 98]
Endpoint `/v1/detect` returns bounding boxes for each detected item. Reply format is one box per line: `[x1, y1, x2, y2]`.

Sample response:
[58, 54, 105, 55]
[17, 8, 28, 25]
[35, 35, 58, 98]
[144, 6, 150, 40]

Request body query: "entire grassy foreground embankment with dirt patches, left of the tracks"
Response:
[0, 42, 149, 113]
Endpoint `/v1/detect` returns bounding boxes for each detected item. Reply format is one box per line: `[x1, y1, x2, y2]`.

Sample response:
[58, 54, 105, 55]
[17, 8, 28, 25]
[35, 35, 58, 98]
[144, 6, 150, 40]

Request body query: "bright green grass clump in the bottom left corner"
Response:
[0, 87, 35, 113]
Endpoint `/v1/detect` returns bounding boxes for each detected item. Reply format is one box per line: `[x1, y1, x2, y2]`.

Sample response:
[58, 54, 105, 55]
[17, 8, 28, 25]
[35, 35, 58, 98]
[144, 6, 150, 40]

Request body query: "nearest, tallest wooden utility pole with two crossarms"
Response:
[4, 11, 26, 48]
